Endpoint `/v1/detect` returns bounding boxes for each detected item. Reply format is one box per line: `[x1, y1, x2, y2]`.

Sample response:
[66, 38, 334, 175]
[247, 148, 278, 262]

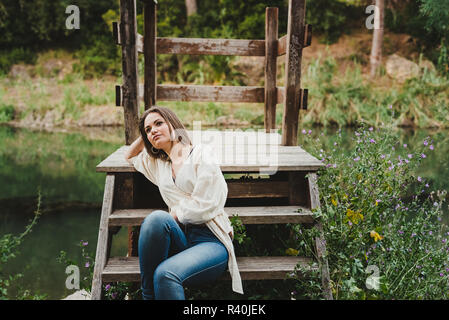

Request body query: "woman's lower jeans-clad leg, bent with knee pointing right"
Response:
[153, 242, 228, 300]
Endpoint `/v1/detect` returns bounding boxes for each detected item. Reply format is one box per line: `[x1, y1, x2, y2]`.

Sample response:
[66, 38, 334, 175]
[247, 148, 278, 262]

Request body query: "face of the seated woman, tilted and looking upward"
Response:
[144, 112, 171, 149]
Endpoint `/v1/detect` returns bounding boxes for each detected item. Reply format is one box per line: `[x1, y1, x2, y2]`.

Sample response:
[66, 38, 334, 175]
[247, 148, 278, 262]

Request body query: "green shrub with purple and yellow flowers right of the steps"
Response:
[293, 122, 449, 299]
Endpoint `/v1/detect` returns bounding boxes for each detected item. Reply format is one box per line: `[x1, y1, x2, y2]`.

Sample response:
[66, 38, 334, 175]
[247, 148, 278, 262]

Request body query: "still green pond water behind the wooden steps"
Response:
[0, 126, 449, 299]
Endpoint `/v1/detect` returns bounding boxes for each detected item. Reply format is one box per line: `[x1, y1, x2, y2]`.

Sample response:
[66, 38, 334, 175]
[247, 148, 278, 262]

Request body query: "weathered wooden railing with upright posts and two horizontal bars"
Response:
[113, 0, 312, 145]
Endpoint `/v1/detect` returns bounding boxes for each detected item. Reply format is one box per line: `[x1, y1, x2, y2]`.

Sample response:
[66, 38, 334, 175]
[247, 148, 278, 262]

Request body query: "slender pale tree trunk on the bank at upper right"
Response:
[370, 0, 385, 77]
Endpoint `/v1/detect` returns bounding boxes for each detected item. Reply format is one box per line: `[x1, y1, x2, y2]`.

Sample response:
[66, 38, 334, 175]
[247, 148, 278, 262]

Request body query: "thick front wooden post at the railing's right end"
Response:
[282, 0, 306, 146]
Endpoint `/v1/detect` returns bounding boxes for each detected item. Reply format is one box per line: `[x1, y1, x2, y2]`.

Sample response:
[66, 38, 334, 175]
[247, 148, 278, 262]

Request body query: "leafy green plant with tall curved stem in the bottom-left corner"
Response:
[0, 190, 45, 300]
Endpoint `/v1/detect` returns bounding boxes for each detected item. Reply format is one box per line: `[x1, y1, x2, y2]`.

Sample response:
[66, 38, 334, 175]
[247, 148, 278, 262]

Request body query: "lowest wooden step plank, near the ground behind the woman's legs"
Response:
[102, 256, 318, 282]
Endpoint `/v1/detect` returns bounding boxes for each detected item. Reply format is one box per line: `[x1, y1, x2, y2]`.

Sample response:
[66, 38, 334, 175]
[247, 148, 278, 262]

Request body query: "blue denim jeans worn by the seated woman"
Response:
[138, 210, 228, 300]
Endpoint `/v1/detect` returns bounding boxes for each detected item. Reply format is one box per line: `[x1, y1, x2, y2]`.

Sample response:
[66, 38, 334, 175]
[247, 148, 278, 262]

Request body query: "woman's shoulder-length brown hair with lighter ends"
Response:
[139, 106, 192, 161]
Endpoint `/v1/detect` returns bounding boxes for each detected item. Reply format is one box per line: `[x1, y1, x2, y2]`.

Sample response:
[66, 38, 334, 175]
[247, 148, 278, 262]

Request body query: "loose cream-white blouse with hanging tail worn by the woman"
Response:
[130, 144, 243, 294]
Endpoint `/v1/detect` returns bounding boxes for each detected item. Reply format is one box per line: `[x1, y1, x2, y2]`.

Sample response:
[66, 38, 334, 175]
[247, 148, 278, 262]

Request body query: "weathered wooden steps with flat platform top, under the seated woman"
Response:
[92, 131, 332, 299]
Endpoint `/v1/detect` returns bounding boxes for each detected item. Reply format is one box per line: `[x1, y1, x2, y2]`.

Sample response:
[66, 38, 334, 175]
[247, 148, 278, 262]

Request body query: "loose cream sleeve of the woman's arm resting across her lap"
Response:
[173, 146, 228, 224]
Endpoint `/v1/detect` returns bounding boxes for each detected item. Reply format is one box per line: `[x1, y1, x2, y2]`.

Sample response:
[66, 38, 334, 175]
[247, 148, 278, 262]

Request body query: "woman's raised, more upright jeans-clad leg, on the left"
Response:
[138, 210, 188, 300]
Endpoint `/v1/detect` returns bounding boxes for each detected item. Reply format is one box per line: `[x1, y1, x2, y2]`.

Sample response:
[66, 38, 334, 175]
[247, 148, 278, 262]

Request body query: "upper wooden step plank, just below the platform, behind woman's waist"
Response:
[109, 206, 315, 226]
